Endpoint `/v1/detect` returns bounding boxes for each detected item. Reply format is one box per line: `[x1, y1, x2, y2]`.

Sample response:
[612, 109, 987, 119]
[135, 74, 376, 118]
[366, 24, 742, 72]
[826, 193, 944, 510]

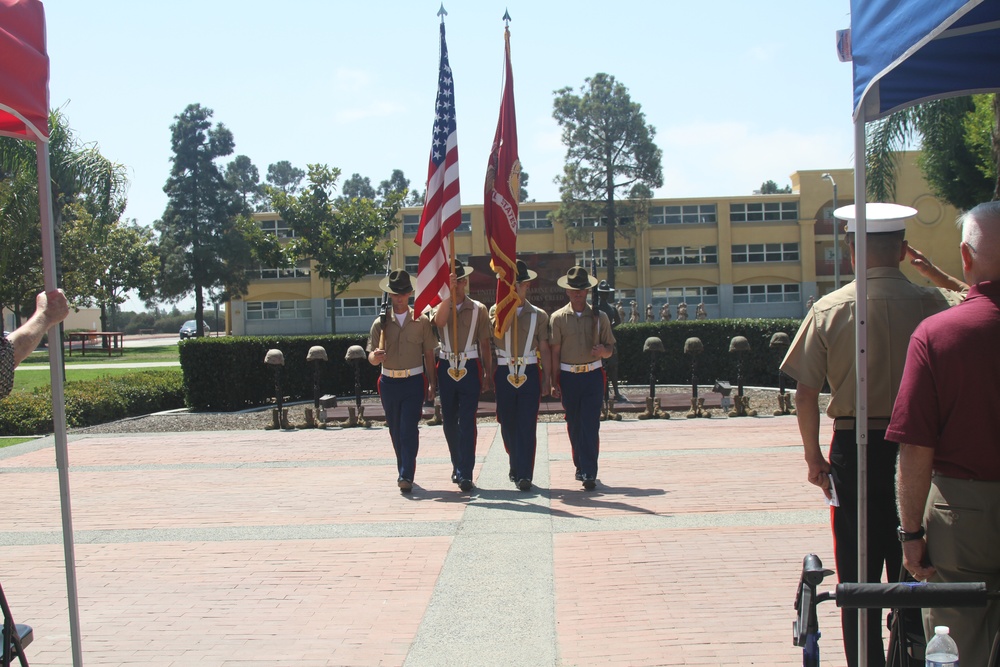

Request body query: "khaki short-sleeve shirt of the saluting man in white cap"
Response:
[781, 268, 962, 419]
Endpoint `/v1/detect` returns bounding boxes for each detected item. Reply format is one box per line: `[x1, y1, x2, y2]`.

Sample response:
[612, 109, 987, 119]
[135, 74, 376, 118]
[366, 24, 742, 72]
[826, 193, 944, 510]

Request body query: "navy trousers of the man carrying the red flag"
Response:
[493, 364, 542, 481]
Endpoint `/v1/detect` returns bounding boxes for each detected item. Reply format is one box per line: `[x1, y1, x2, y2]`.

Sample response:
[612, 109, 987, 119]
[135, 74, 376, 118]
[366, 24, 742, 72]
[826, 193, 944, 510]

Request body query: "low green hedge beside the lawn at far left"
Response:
[0, 370, 184, 435]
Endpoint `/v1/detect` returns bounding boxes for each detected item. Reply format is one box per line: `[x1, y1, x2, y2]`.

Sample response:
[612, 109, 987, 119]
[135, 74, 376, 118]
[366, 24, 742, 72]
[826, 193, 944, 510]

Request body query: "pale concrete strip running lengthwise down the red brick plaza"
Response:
[404, 426, 557, 666]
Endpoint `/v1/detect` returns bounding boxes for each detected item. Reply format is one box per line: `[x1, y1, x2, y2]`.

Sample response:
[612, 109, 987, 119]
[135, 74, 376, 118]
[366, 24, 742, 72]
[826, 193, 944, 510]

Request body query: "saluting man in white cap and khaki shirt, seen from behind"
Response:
[781, 204, 961, 667]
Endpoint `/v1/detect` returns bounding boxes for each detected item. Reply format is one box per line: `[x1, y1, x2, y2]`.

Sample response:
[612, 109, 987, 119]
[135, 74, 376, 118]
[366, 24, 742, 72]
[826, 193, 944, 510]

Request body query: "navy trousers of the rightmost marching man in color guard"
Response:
[559, 368, 605, 477]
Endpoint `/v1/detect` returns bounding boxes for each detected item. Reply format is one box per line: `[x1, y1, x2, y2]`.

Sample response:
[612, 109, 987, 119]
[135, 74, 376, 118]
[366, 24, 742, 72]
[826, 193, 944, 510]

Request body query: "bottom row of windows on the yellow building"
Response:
[246, 283, 801, 320]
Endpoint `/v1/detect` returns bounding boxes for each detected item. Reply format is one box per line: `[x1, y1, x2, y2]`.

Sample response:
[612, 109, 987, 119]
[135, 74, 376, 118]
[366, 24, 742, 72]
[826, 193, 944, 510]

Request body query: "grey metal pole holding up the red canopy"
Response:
[35, 141, 83, 667]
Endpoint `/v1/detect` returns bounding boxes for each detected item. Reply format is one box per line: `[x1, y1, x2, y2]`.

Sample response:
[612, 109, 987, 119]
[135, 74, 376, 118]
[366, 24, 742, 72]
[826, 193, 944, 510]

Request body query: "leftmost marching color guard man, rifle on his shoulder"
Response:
[367, 270, 437, 493]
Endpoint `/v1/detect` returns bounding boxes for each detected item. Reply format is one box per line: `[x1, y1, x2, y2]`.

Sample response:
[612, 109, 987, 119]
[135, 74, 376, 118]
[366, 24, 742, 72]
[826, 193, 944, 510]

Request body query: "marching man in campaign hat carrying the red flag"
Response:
[490, 260, 552, 491]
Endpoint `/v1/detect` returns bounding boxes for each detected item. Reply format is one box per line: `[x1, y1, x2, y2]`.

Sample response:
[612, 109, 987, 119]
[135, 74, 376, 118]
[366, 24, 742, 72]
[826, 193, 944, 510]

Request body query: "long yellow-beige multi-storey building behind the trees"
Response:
[227, 152, 961, 335]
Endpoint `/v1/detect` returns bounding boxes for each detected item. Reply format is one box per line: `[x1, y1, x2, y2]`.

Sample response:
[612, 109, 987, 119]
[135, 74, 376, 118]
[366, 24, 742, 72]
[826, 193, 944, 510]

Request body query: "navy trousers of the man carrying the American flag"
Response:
[437, 359, 482, 480]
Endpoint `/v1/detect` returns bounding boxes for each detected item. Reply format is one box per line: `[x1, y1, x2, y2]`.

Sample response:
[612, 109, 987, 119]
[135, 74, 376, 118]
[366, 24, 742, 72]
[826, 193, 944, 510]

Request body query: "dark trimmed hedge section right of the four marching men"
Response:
[615, 319, 799, 387]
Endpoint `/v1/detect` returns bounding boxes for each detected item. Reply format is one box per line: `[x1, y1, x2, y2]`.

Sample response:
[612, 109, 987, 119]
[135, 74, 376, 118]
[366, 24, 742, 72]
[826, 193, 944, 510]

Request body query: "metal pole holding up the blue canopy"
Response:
[854, 115, 868, 667]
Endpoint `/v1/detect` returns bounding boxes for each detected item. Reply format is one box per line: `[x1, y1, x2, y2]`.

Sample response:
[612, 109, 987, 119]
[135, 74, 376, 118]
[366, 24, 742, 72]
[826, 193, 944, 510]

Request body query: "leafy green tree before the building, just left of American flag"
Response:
[270, 164, 403, 333]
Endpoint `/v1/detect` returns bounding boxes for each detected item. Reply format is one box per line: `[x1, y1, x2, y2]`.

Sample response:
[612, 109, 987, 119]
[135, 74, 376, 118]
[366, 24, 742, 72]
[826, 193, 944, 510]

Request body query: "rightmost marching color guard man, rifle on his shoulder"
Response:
[549, 266, 615, 490]
